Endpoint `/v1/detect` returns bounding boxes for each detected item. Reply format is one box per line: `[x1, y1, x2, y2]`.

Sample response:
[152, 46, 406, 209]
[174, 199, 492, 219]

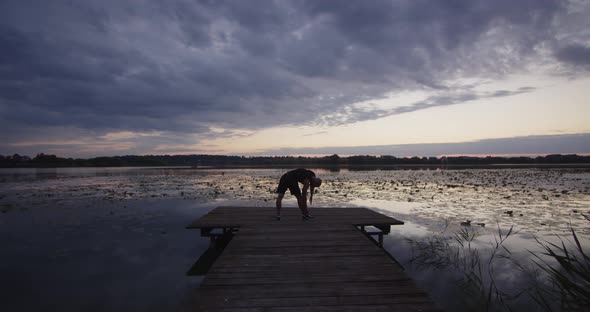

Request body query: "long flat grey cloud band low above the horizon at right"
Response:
[252, 133, 590, 157]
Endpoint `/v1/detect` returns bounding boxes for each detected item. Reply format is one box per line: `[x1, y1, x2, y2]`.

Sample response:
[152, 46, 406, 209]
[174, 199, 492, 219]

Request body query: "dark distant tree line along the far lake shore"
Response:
[0, 153, 590, 168]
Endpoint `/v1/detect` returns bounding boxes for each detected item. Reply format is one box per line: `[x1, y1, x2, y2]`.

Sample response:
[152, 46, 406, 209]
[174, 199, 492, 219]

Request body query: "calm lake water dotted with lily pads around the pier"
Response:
[0, 168, 590, 311]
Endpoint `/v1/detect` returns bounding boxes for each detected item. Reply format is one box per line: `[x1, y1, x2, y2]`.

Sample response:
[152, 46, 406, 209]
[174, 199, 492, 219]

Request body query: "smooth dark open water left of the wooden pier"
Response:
[0, 200, 217, 311]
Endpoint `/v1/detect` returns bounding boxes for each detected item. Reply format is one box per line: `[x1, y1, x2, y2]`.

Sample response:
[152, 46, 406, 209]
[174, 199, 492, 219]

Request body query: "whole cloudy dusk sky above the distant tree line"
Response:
[0, 0, 590, 157]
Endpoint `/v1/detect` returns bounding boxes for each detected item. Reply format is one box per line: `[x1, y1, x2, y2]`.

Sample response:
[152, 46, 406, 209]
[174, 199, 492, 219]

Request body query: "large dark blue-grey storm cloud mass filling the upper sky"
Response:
[0, 0, 588, 155]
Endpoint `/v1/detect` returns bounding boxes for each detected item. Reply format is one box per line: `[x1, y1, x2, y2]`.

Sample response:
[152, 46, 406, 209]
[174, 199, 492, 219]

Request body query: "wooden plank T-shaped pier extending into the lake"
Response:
[187, 207, 439, 312]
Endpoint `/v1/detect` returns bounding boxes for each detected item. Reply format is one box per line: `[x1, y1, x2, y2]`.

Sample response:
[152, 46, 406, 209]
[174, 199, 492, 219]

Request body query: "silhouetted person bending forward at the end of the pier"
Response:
[277, 168, 322, 220]
